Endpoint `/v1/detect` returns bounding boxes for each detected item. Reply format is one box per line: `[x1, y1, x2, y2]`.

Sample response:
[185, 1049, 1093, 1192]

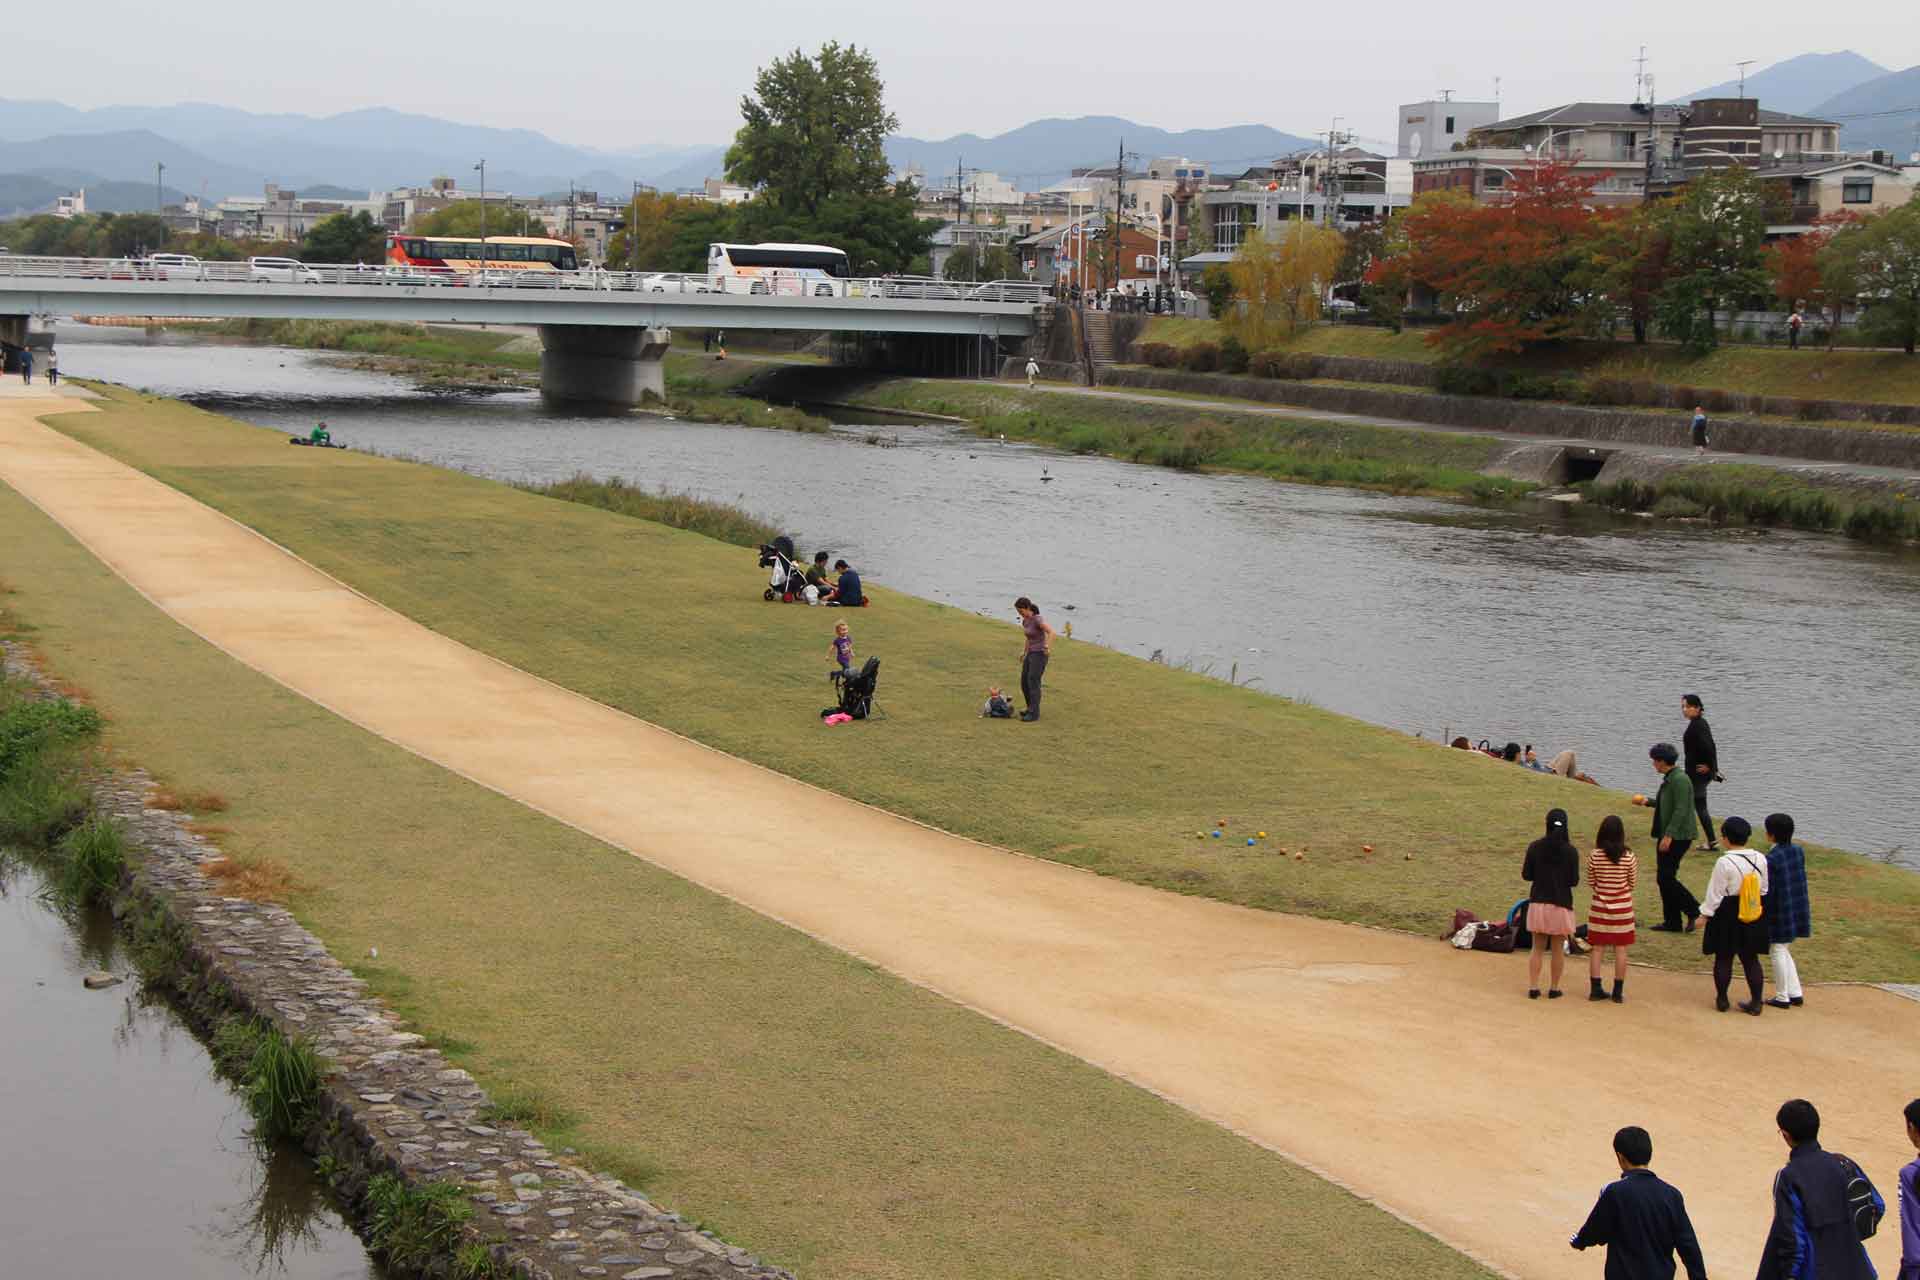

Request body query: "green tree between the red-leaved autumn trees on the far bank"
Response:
[1653, 165, 1768, 351]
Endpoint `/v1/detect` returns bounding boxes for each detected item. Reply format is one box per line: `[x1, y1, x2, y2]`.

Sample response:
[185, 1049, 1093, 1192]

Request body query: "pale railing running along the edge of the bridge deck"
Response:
[0, 253, 1046, 305]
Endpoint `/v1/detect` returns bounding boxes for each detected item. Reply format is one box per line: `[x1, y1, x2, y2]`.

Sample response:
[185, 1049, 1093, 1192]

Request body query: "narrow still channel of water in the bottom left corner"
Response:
[0, 852, 380, 1280]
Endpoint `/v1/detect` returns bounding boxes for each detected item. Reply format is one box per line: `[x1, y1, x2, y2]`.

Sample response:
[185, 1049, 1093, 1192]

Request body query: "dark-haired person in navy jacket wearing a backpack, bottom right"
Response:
[1757, 1098, 1880, 1280]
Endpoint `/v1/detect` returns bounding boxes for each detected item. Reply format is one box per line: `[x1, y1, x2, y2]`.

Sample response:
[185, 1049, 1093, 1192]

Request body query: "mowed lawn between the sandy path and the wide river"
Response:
[41, 393, 1920, 981]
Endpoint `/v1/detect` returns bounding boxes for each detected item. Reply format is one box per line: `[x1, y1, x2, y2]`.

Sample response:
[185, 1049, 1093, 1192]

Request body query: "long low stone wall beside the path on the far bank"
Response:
[1098, 367, 1920, 468]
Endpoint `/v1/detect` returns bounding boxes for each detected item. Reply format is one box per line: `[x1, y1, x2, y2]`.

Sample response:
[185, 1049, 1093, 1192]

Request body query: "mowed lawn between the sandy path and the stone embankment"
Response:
[0, 458, 1488, 1280]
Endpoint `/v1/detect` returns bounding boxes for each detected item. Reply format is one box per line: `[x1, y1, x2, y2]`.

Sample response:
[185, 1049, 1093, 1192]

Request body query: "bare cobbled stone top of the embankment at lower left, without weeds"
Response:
[4, 647, 793, 1280]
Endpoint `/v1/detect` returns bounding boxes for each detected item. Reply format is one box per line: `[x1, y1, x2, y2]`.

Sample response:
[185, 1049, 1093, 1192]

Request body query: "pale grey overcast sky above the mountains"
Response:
[18, 0, 1920, 148]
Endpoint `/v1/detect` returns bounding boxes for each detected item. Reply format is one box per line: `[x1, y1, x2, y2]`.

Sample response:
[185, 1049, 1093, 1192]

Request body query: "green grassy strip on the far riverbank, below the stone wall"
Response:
[751, 368, 1532, 501]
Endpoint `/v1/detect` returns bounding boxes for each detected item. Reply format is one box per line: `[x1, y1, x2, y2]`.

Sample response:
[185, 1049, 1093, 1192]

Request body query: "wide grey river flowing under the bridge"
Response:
[60, 326, 1920, 867]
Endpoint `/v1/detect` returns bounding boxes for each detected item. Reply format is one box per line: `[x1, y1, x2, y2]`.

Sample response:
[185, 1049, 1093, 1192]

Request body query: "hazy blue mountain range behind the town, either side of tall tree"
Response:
[0, 98, 1308, 215]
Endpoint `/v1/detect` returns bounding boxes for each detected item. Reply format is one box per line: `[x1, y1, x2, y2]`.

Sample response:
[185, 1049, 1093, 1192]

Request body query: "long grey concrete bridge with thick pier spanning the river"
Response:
[0, 255, 1044, 405]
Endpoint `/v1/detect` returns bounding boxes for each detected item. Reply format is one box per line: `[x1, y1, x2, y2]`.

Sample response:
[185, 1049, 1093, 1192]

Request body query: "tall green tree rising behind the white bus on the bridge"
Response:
[726, 40, 900, 215]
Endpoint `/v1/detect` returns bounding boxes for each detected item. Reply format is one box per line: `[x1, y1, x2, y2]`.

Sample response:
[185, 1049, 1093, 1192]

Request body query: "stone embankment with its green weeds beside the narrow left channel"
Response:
[0, 639, 791, 1280]
